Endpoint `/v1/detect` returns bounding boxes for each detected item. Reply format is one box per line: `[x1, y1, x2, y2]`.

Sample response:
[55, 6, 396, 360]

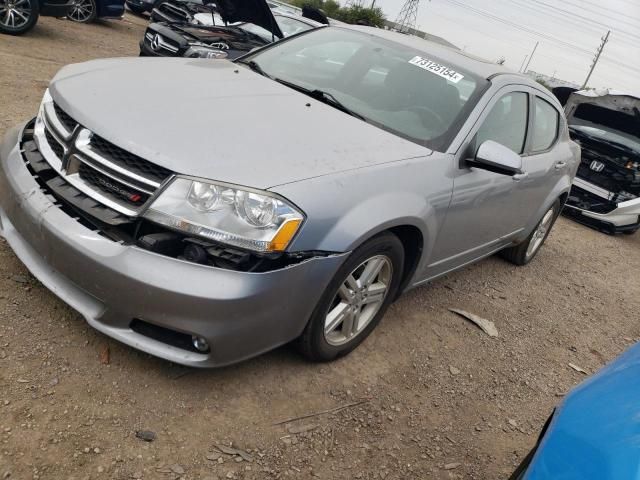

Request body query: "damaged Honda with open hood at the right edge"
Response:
[565, 90, 640, 233]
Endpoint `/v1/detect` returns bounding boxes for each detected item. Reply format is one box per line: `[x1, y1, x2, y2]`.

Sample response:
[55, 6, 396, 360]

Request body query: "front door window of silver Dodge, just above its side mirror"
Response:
[475, 92, 529, 153]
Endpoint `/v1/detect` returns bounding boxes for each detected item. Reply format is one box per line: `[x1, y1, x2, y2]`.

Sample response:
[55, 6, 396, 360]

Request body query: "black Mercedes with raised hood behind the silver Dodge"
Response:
[140, 0, 323, 59]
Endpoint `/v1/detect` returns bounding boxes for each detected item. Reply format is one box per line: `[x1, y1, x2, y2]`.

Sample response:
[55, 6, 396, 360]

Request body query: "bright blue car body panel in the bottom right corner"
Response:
[524, 344, 640, 480]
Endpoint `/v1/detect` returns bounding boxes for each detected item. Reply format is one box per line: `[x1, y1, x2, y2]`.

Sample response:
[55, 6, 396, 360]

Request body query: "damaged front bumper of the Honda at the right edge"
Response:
[563, 178, 640, 234]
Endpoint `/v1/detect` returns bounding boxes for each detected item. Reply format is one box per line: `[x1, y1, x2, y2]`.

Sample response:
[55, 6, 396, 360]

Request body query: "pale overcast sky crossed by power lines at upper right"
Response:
[372, 0, 640, 96]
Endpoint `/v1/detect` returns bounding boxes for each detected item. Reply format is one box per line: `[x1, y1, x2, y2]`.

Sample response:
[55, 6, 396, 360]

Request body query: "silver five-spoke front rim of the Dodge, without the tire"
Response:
[324, 255, 393, 346]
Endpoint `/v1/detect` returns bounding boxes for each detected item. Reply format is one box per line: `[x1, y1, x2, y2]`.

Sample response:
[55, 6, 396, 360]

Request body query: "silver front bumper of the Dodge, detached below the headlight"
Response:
[0, 127, 347, 367]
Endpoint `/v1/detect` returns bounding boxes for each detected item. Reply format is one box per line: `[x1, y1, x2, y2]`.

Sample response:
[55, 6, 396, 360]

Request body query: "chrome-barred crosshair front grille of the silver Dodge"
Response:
[35, 100, 172, 217]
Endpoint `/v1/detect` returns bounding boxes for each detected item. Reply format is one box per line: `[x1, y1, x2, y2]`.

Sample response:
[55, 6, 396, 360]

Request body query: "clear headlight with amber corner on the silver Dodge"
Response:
[144, 177, 304, 252]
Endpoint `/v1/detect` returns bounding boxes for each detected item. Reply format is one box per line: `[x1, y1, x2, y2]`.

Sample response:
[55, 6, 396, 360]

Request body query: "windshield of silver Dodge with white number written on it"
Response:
[245, 27, 487, 150]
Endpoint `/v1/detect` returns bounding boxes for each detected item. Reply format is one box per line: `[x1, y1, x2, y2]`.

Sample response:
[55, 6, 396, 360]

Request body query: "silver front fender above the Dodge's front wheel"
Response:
[273, 154, 453, 257]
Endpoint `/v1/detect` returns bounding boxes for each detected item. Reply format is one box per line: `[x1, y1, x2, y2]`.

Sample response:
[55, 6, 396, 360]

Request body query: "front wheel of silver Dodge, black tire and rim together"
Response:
[296, 232, 404, 362]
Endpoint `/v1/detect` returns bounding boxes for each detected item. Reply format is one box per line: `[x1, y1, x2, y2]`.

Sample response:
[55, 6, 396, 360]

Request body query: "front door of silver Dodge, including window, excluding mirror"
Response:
[427, 86, 531, 277]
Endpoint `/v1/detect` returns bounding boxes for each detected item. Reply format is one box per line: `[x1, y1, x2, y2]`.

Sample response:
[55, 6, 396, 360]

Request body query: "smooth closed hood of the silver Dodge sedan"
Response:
[50, 58, 431, 188]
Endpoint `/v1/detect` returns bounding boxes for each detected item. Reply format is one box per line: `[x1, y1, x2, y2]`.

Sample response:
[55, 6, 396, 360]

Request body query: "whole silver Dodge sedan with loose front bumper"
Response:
[0, 26, 580, 366]
